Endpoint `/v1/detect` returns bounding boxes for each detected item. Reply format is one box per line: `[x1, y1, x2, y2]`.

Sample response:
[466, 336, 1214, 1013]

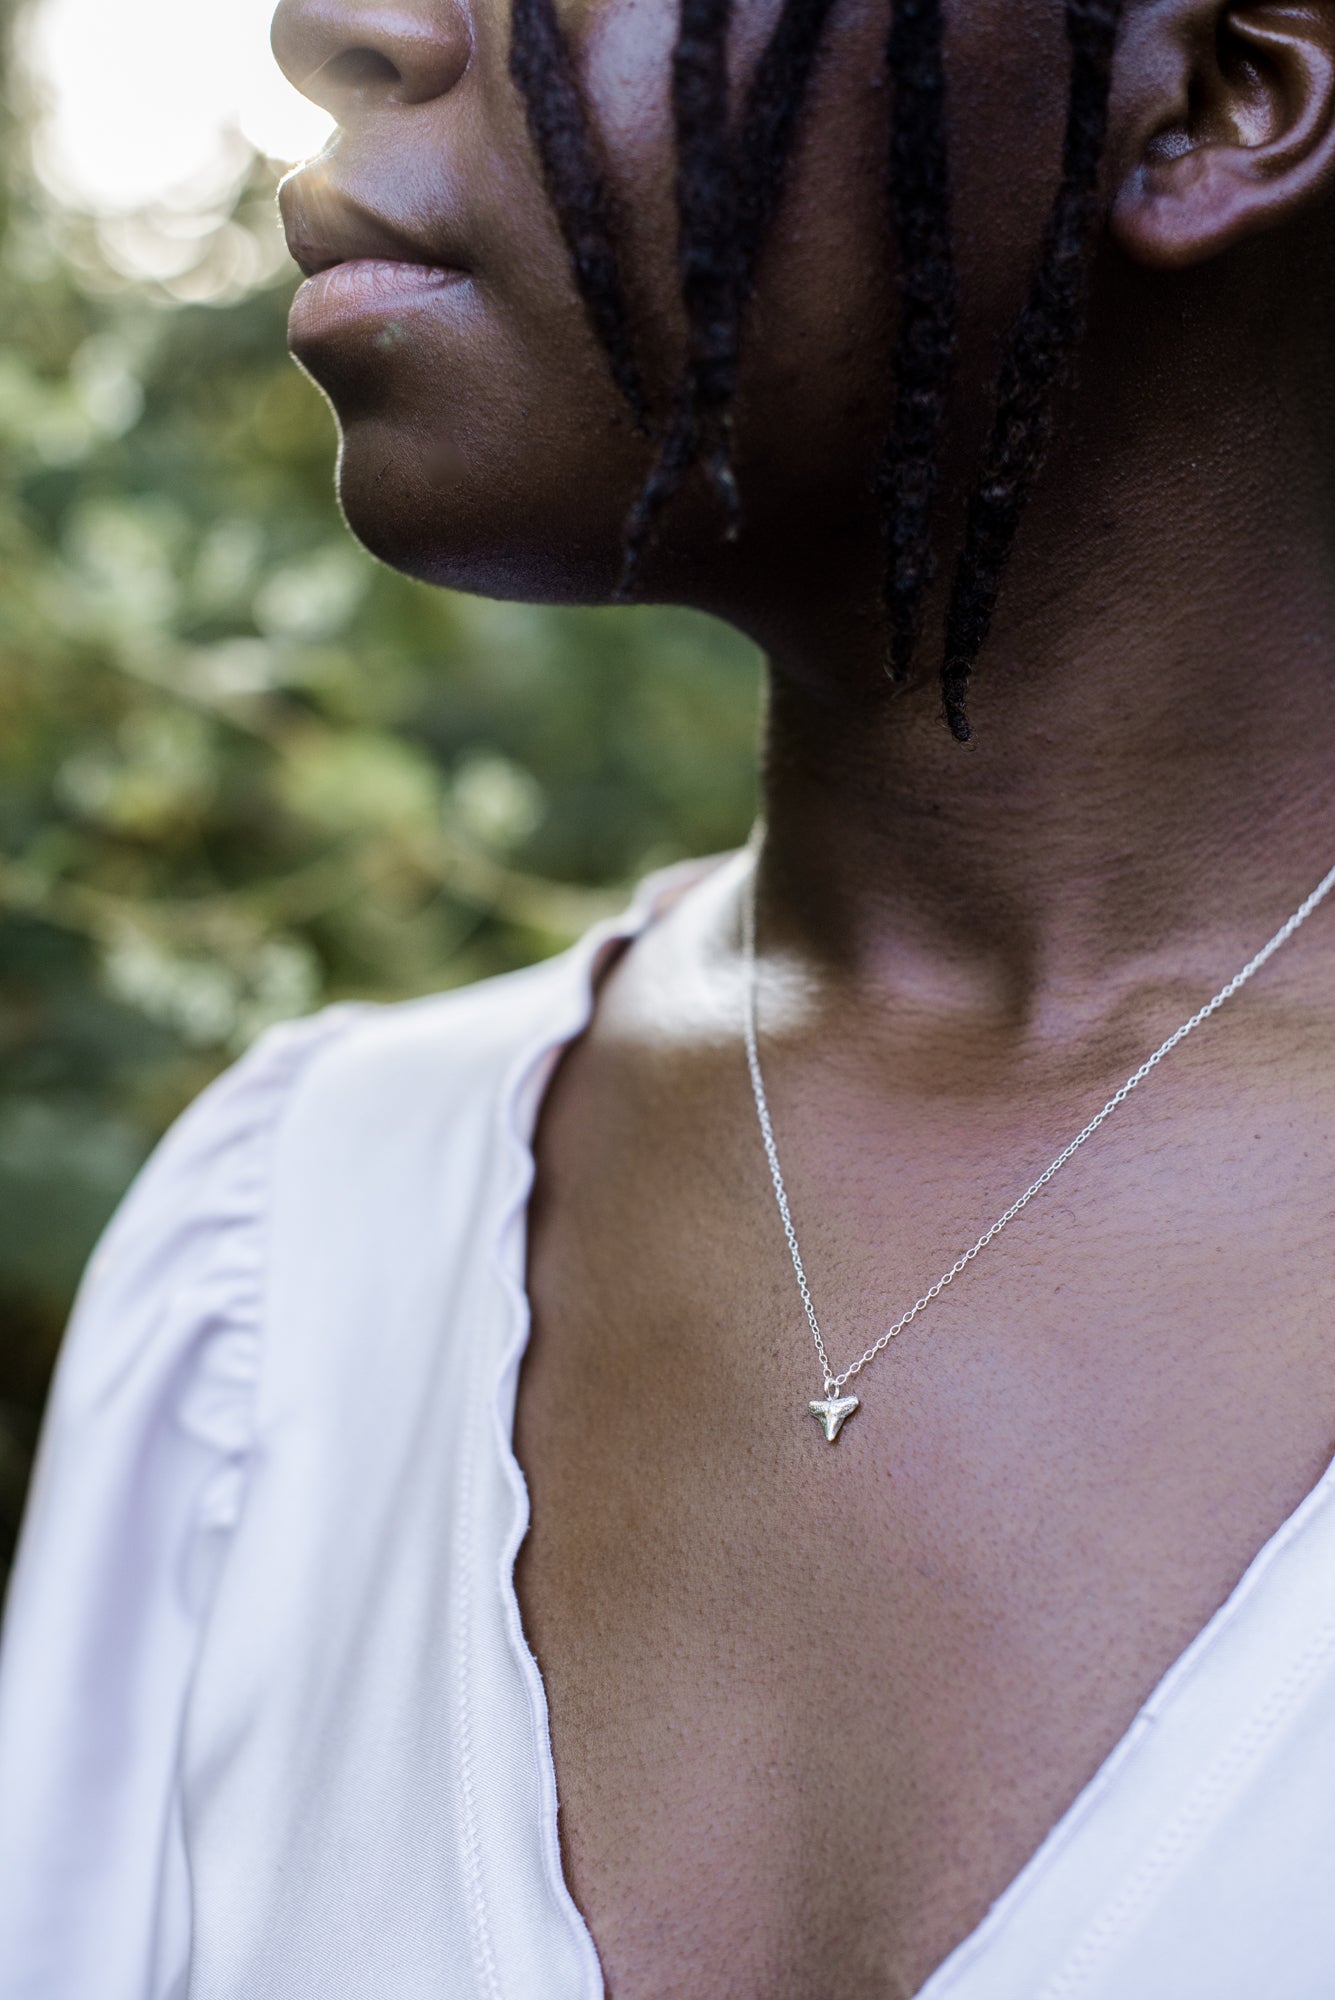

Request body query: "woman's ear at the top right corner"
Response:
[1111, 0, 1335, 270]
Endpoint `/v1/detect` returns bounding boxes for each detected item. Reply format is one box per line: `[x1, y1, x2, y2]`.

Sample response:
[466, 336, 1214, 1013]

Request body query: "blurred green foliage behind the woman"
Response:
[0, 0, 757, 1568]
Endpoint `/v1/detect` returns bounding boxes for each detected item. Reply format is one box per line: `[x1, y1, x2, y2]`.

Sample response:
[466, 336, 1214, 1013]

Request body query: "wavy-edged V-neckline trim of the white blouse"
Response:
[496, 856, 1335, 2000]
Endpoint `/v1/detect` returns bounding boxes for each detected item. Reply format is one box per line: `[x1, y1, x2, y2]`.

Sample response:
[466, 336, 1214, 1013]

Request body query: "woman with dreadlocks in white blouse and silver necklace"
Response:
[0, 0, 1335, 2000]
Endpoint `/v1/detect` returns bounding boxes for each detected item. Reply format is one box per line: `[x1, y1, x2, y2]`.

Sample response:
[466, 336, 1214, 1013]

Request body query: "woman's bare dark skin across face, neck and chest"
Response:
[276, 0, 1335, 2000]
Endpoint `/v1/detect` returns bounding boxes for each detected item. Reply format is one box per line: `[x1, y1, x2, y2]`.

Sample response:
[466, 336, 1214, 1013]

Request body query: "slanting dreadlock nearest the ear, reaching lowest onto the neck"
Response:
[941, 0, 1123, 742]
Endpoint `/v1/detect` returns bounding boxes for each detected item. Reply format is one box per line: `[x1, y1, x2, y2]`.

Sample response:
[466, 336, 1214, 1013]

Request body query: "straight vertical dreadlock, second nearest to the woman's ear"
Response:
[877, 0, 957, 680]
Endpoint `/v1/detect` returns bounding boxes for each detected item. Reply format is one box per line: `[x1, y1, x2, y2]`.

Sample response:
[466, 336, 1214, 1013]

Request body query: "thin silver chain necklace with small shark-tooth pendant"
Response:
[741, 852, 1335, 1444]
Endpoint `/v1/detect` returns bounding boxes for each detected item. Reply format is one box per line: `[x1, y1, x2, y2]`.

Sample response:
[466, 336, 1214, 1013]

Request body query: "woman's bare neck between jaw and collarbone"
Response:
[751, 356, 1335, 1022]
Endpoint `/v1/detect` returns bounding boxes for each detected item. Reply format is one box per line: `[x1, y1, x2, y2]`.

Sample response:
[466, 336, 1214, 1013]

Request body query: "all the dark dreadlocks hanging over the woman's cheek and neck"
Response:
[510, 0, 1125, 742]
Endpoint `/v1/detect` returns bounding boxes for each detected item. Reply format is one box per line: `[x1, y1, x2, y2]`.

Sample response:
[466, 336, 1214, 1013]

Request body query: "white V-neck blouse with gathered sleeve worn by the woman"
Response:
[0, 860, 1335, 2000]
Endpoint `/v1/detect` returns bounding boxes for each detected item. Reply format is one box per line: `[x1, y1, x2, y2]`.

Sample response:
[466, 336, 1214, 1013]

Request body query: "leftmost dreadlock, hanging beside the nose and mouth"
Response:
[510, 0, 648, 430]
